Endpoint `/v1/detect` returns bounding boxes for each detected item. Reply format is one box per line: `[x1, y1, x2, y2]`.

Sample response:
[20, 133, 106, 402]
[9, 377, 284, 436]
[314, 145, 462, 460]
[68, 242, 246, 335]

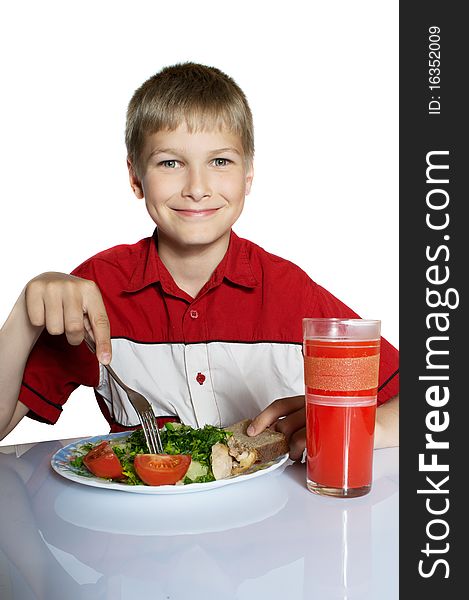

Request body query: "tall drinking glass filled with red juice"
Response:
[303, 319, 381, 497]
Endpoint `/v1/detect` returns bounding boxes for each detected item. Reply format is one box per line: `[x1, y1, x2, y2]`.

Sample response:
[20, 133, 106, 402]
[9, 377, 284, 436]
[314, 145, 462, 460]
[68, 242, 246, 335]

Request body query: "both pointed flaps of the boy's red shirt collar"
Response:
[125, 229, 258, 294]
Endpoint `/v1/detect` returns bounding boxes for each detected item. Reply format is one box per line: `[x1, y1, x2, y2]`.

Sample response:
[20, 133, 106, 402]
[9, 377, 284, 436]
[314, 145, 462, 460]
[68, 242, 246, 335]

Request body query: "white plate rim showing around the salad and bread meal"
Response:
[51, 431, 288, 494]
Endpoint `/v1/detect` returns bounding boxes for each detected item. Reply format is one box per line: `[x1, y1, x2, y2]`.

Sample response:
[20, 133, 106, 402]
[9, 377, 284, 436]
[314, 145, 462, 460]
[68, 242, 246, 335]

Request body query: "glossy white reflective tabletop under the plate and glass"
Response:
[0, 440, 399, 600]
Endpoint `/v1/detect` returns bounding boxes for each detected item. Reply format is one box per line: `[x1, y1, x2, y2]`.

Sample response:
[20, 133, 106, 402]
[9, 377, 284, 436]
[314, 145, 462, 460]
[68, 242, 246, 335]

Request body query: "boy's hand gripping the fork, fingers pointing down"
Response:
[26, 273, 112, 364]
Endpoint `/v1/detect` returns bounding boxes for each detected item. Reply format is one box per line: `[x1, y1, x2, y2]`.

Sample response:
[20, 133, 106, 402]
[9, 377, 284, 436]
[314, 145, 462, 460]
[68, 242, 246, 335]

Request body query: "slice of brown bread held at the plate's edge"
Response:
[225, 419, 289, 463]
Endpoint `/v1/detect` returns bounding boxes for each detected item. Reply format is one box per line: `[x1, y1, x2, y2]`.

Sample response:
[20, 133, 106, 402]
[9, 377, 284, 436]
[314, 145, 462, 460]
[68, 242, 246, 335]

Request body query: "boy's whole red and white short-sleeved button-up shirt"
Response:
[19, 232, 399, 431]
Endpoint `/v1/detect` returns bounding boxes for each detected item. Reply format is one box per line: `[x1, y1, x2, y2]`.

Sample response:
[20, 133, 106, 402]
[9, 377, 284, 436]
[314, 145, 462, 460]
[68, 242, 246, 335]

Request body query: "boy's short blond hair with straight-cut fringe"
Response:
[125, 62, 254, 176]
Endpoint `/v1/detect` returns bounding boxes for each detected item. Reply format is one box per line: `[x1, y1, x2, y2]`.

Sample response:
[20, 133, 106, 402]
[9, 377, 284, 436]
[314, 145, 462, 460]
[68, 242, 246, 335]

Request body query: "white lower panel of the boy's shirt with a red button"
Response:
[96, 339, 304, 427]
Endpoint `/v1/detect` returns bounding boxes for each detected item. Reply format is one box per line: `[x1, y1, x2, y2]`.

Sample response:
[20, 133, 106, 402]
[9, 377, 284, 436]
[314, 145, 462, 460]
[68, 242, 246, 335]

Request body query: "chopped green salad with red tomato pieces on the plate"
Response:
[70, 423, 232, 485]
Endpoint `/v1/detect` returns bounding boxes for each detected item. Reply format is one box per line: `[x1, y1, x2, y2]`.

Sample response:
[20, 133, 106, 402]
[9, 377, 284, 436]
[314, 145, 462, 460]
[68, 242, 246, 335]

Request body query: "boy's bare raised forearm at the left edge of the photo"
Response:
[0, 290, 43, 439]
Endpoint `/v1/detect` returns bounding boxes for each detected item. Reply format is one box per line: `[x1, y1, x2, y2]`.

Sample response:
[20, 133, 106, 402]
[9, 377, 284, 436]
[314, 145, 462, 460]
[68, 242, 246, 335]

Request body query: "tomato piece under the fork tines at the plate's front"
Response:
[134, 454, 191, 485]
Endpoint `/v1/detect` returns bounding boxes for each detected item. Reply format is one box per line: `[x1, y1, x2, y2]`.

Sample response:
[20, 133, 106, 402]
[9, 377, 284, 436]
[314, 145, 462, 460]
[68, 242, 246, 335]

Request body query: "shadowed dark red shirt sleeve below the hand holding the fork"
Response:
[19, 330, 99, 424]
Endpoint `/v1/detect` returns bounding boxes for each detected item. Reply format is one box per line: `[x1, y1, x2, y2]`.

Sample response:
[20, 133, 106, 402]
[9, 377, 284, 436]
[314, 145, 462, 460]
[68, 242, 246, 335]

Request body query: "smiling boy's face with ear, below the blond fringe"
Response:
[129, 125, 253, 249]
